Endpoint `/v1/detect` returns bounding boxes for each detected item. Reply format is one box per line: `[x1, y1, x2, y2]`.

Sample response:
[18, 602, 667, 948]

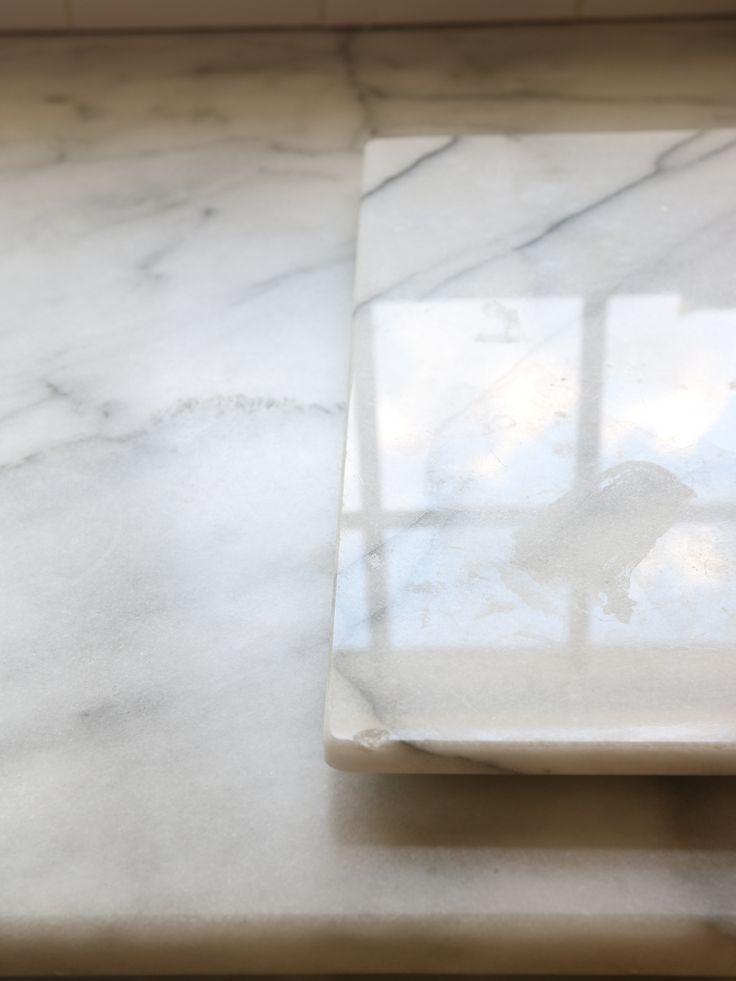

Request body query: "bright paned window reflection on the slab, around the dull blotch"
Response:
[335, 294, 736, 663]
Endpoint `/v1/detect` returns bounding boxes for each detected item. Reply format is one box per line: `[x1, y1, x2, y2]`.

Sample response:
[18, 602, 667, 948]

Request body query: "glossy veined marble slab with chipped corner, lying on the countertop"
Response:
[326, 130, 736, 773]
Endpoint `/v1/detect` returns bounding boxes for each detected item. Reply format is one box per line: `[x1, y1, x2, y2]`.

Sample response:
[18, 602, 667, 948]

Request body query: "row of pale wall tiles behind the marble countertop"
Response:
[0, 0, 736, 31]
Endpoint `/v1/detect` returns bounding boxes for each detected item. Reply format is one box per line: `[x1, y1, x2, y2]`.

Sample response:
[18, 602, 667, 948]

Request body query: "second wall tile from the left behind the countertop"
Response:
[71, 0, 320, 29]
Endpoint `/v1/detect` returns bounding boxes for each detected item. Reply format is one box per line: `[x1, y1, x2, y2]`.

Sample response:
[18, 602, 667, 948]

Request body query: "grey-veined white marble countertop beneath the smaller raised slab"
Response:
[0, 21, 736, 975]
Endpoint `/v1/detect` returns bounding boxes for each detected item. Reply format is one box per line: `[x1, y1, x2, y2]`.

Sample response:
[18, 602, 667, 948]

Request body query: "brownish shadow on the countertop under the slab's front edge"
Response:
[331, 772, 736, 850]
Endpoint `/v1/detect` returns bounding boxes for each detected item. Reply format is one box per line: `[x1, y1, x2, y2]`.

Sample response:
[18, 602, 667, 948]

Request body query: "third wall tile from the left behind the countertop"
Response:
[323, 0, 575, 26]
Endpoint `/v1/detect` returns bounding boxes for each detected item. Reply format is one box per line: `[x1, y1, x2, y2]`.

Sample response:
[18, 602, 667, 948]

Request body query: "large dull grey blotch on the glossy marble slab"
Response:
[513, 460, 694, 623]
